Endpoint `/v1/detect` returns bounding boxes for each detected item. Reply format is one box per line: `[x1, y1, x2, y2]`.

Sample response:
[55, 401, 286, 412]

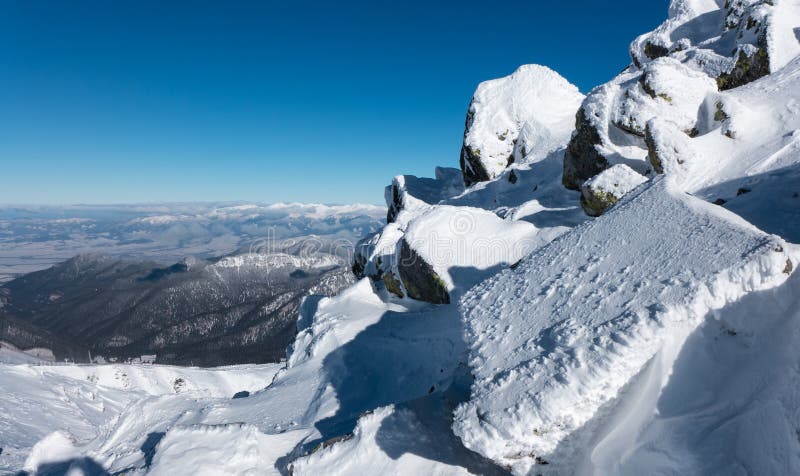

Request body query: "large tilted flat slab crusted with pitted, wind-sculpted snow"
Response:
[454, 179, 793, 474]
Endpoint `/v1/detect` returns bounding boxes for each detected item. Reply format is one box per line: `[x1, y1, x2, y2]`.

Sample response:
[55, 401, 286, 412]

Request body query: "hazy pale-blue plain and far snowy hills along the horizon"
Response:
[0, 203, 386, 282]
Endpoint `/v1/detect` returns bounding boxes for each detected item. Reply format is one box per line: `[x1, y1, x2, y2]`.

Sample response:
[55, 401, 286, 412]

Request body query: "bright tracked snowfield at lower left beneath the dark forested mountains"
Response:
[0, 360, 279, 473]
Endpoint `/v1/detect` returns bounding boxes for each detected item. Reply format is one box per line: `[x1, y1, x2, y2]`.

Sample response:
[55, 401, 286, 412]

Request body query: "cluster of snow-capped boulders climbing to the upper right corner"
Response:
[563, 0, 800, 190]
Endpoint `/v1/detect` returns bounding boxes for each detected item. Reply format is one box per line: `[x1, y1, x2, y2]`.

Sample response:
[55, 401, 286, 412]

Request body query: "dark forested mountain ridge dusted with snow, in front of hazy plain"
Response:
[0, 249, 354, 366]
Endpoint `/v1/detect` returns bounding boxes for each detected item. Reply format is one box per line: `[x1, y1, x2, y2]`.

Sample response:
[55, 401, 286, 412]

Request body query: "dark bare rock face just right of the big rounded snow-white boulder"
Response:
[562, 108, 609, 190]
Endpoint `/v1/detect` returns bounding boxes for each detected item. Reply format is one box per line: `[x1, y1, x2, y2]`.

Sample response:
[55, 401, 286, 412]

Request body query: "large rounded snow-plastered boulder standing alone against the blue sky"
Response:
[459, 65, 583, 186]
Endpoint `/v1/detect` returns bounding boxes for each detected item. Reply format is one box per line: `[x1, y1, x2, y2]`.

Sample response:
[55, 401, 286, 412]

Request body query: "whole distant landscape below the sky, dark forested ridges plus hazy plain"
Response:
[0, 204, 385, 366]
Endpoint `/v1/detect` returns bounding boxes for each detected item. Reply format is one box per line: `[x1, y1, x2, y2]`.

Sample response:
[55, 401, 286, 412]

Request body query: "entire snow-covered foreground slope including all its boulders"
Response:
[0, 0, 800, 476]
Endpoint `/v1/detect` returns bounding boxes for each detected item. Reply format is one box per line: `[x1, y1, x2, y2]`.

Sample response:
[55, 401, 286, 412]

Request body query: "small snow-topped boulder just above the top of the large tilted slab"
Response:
[581, 164, 647, 217]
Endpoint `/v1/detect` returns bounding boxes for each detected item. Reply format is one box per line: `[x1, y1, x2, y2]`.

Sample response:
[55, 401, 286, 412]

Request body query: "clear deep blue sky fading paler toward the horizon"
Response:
[0, 0, 668, 204]
